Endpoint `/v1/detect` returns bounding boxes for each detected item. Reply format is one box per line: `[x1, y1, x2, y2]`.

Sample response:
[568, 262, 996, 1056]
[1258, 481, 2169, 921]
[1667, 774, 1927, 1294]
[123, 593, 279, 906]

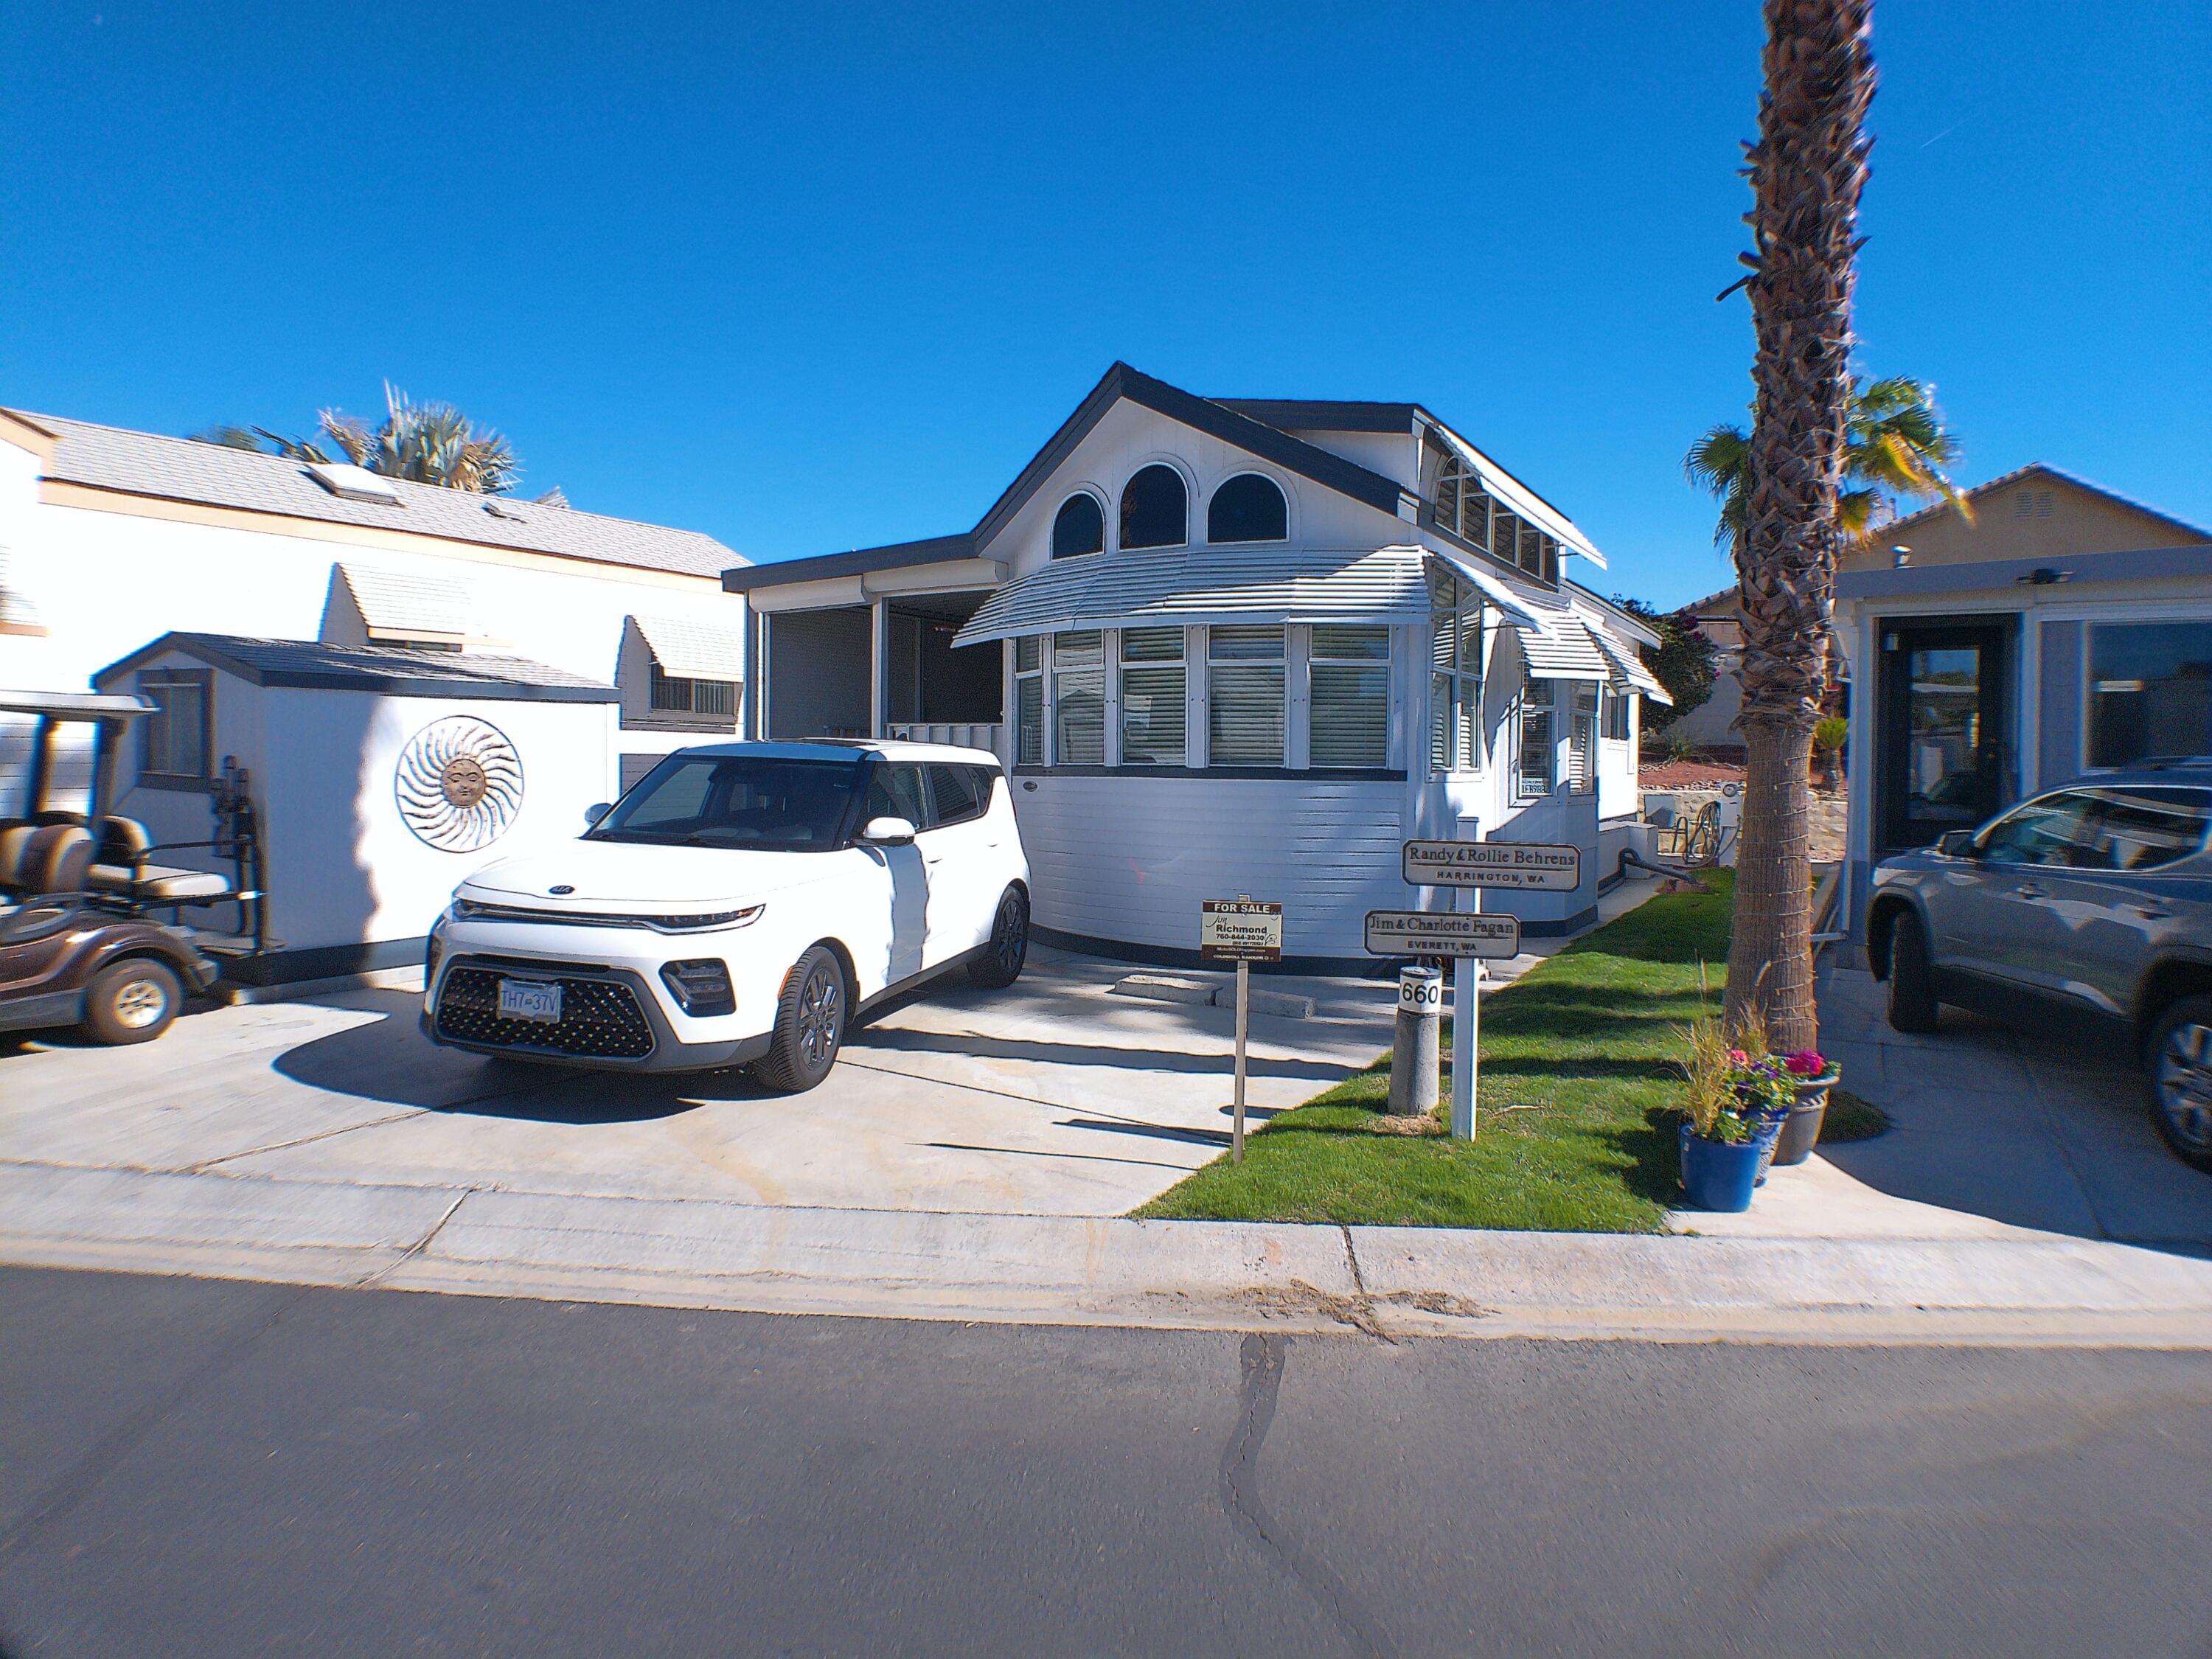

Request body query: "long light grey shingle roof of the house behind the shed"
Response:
[0, 409, 745, 577]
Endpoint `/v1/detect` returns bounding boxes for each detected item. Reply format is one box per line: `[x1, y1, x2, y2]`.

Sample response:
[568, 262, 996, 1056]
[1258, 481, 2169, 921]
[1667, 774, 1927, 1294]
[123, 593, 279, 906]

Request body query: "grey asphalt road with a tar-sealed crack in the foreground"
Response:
[0, 1270, 2212, 1659]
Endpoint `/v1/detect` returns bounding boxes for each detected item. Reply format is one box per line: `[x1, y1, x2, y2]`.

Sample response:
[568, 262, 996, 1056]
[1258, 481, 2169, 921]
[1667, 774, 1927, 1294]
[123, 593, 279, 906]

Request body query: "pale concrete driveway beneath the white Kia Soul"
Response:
[0, 949, 1396, 1217]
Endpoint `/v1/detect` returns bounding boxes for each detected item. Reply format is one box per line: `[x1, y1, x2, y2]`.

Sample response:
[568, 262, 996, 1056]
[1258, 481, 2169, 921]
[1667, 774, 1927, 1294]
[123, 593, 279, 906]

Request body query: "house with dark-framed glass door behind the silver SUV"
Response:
[1836, 465, 2212, 920]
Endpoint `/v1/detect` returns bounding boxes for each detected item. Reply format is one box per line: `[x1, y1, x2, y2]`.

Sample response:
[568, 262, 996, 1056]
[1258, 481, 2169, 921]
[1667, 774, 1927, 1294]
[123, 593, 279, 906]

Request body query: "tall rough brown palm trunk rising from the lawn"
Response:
[1723, 0, 1874, 1053]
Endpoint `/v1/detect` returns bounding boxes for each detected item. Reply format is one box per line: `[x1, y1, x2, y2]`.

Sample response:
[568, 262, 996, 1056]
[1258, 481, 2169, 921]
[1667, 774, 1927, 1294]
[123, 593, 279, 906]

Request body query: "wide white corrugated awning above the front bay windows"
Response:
[953, 546, 1429, 646]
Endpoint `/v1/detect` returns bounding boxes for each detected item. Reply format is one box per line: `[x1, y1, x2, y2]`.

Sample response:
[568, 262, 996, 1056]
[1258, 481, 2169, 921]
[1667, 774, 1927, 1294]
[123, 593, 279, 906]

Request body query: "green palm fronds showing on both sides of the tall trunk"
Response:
[1681, 374, 1973, 560]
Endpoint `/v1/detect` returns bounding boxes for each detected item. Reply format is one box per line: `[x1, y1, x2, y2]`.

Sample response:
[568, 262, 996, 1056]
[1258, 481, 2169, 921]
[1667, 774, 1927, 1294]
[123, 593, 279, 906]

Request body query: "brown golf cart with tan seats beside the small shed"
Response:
[0, 692, 221, 1042]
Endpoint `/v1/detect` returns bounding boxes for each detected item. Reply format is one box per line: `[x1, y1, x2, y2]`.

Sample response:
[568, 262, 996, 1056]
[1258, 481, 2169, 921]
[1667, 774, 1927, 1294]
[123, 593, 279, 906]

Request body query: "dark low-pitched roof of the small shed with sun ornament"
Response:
[93, 633, 622, 703]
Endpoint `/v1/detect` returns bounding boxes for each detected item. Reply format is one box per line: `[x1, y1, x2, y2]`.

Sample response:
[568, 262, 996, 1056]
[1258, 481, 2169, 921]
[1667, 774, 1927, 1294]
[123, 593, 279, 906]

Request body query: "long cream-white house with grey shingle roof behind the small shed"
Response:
[0, 409, 743, 810]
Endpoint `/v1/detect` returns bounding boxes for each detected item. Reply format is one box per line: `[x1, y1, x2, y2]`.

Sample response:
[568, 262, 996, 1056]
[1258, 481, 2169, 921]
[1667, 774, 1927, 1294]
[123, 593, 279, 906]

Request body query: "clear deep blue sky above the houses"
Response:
[0, 0, 2212, 602]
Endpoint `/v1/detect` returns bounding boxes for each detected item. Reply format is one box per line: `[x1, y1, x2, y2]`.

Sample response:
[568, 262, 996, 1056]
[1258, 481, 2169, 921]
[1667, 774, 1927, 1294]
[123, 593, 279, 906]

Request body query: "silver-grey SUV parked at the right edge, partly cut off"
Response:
[1867, 759, 2212, 1172]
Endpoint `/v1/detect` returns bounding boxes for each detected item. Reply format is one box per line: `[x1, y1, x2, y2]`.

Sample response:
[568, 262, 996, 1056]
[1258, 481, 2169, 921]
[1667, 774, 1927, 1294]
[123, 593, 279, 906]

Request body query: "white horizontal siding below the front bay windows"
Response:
[1013, 776, 1411, 956]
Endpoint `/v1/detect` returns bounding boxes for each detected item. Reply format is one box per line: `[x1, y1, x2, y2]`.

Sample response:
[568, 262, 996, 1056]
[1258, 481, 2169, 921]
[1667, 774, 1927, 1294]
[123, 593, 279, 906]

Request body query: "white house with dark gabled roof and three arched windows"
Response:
[723, 363, 1661, 964]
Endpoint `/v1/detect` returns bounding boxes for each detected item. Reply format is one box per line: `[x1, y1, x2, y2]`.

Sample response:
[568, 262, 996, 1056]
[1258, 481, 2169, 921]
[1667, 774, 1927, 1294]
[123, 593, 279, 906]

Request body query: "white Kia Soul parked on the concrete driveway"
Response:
[422, 743, 1029, 1091]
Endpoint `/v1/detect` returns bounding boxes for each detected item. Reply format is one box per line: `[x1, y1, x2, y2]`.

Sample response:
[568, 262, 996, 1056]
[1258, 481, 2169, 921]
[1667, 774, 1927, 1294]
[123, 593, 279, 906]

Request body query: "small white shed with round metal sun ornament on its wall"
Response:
[93, 633, 617, 984]
